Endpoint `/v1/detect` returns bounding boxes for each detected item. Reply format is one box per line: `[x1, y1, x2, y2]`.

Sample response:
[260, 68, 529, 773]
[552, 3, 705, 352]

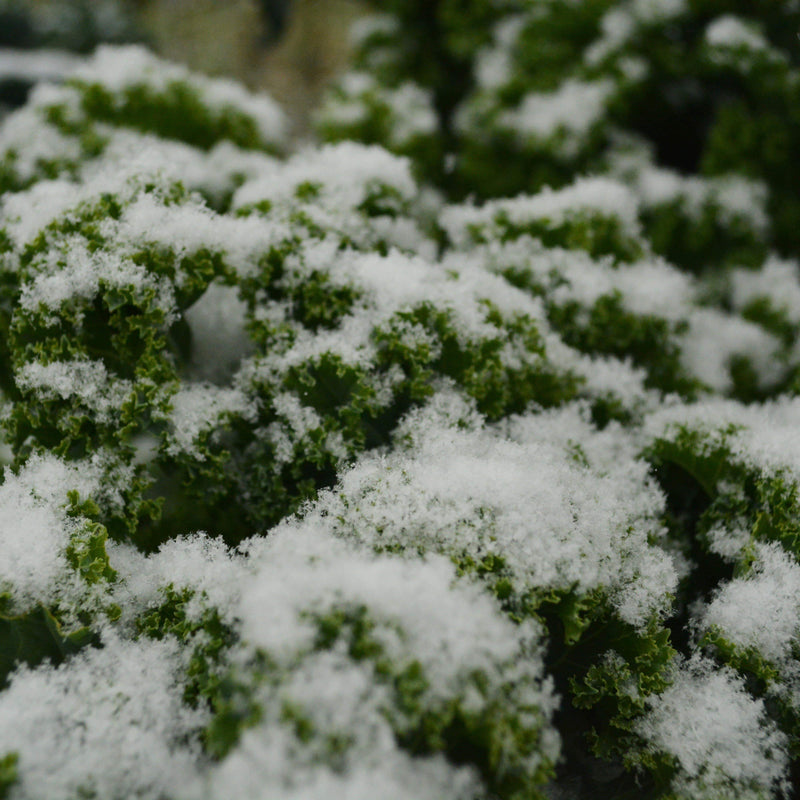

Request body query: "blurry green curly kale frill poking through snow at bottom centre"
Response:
[206, 606, 551, 798]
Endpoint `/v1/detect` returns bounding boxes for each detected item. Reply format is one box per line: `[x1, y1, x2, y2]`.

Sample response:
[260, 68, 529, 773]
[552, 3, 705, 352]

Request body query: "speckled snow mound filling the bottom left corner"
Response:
[0, 638, 206, 800]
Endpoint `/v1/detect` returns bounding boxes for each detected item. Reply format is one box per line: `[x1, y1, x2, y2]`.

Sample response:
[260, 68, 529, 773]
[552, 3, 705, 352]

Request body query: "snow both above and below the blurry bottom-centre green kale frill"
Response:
[211, 520, 559, 799]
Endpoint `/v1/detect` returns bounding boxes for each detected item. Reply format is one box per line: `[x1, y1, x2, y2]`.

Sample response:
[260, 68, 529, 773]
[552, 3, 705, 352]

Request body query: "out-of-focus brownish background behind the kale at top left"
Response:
[0, 0, 364, 135]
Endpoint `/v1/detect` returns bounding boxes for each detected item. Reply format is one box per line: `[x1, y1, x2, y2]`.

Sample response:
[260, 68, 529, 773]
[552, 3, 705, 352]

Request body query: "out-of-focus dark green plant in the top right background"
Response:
[322, 0, 800, 272]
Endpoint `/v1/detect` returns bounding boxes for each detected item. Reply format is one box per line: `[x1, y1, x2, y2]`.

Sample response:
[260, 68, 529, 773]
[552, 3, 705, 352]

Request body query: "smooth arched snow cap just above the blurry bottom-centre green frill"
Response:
[240, 518, 552, 699]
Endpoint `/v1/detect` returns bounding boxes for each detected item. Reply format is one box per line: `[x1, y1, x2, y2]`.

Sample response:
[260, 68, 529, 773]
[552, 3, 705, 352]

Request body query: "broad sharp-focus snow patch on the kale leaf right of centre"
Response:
[290, 398, 675, 625]
